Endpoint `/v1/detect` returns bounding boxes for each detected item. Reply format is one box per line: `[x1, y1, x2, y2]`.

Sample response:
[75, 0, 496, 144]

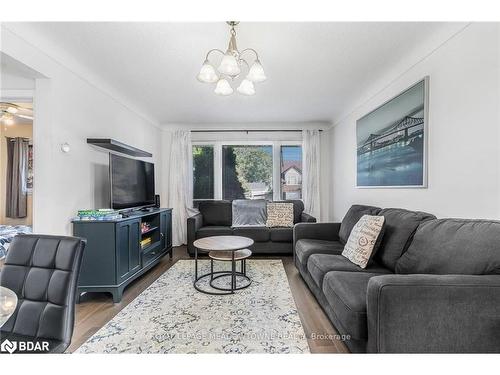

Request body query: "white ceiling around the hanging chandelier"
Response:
[6, 22, 460, 124]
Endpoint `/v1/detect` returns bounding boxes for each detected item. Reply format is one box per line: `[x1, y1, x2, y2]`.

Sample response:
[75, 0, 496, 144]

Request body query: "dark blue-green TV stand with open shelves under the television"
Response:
[73, 207, 172, 303]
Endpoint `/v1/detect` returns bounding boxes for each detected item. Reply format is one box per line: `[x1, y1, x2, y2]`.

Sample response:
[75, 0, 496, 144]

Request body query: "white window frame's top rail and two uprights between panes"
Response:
[191, 140, 304, 201]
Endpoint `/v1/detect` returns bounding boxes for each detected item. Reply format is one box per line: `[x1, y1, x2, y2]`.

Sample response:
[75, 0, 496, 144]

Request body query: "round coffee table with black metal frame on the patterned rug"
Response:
[193, 236, 253, 295]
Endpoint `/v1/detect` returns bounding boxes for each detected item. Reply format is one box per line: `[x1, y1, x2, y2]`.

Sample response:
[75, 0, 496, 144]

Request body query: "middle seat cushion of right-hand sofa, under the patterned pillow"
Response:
[307, 254, 392, 288]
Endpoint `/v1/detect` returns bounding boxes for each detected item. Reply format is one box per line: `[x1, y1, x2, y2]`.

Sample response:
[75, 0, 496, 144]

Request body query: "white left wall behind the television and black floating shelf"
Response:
[1, 26, 161, 234]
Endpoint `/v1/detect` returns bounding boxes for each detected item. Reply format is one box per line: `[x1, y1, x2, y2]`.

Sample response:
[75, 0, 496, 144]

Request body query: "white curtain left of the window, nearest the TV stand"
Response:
[168, 130, 195, 246]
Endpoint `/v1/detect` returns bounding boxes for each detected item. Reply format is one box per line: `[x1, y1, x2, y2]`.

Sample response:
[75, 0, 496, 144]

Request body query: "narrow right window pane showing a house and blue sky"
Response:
[280, 146, 302, 199]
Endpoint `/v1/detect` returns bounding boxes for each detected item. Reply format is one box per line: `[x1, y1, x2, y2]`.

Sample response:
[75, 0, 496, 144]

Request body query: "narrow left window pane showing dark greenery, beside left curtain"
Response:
[193, 145, 215, 199]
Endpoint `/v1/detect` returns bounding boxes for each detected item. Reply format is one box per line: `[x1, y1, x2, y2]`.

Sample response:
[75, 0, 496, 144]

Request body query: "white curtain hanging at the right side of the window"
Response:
[302, 130, 320, 221]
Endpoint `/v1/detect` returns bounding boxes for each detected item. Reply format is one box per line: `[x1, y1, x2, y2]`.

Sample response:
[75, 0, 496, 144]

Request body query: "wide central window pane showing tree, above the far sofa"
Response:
[222, 145, 273, 200]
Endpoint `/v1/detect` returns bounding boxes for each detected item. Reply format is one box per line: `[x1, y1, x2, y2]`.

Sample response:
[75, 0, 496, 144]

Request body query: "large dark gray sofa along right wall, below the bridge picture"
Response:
[294, 205, 500, 353]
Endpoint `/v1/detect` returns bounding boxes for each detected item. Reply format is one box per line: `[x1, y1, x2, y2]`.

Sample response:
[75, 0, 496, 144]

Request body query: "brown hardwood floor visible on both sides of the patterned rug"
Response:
[68, 246, 349, 353]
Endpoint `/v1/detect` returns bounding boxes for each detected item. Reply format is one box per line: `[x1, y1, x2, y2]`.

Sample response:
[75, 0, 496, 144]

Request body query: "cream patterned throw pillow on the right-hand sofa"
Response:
[342, 215, 385, 268]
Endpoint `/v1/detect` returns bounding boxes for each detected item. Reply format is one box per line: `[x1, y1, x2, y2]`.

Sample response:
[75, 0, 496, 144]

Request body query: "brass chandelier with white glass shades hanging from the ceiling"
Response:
[198, 21, 266, 96]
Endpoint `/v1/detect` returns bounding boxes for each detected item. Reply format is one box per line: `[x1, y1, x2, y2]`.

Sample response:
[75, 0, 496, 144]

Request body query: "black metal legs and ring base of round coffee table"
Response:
[193, 249, 252, 296]
